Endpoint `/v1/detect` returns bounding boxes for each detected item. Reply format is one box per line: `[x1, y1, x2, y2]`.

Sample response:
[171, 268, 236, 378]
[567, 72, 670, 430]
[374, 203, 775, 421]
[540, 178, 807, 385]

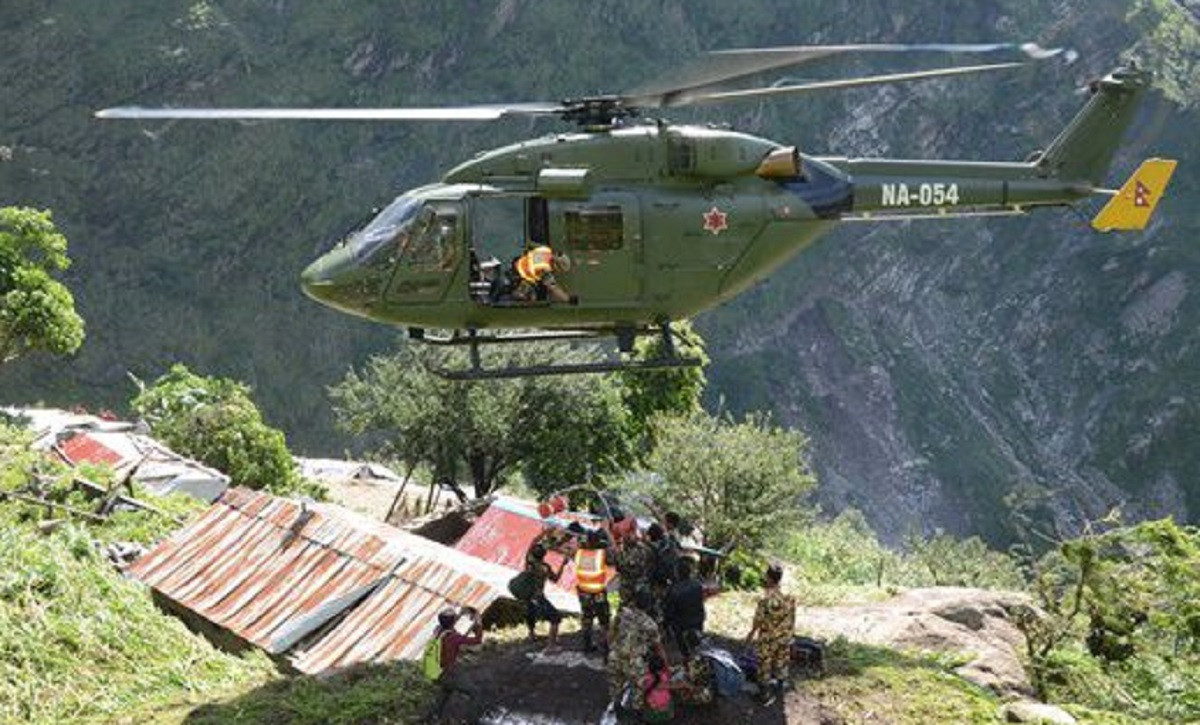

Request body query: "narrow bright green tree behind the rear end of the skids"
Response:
[619, 320, 708, 459]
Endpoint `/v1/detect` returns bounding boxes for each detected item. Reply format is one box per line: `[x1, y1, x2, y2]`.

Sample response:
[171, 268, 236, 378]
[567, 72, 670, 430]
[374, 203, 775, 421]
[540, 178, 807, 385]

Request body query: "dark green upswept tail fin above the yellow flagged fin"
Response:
[1037, 65, 1150, 186]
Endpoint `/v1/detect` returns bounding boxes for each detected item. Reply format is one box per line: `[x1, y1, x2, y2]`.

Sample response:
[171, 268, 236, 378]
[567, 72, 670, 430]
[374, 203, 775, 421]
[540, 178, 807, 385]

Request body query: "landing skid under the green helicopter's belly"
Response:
[409, 323, 702, 381]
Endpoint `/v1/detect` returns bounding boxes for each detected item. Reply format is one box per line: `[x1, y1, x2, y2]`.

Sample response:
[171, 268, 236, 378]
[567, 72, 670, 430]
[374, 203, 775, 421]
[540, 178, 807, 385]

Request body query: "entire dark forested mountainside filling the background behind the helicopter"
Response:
[0, 0, 1200, 543]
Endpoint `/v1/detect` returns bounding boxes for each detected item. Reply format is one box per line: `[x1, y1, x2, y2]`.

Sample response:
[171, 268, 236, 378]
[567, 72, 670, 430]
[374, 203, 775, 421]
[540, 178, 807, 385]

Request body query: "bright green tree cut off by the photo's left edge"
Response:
[0, 206, 83, 365]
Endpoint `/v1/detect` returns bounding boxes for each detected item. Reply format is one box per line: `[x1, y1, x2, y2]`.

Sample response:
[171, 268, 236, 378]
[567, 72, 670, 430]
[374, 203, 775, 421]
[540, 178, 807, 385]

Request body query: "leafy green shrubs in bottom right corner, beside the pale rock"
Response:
[1016, 515, 1200, 723]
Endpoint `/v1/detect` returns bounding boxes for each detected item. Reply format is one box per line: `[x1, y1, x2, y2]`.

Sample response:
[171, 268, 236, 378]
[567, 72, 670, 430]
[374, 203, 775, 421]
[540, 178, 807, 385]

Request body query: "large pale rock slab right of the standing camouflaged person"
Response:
[797, 587, 1033, 697]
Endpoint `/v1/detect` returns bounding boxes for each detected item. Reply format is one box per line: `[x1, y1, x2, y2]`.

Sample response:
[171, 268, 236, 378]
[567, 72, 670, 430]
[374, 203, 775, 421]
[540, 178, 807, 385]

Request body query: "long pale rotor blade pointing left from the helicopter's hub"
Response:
[96, 103, 563, 121]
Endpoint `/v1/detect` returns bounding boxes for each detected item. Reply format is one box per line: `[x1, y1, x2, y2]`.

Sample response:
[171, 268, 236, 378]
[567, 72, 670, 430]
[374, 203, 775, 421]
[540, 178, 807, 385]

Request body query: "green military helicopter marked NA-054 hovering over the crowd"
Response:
[96, 43, 1176, 379]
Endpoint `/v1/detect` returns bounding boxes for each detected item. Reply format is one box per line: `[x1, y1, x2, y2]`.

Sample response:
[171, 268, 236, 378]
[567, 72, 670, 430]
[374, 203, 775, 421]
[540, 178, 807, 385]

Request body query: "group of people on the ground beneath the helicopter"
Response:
[426, 504, 796, 721]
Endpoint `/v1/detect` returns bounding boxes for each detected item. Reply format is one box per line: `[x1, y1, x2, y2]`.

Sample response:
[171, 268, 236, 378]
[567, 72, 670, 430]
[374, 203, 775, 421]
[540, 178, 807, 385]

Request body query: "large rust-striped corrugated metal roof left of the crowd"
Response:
[128, 489, 578, 673]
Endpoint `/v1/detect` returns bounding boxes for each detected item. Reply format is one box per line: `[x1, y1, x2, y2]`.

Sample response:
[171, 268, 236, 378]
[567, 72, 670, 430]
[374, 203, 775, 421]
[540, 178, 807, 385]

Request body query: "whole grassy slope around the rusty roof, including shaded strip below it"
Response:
[0, 489, 431, 724]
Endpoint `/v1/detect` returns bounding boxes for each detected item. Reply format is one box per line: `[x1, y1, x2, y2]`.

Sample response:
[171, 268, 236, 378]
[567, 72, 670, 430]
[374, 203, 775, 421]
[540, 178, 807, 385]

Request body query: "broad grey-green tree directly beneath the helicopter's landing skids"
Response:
[330, 343, 631, 496]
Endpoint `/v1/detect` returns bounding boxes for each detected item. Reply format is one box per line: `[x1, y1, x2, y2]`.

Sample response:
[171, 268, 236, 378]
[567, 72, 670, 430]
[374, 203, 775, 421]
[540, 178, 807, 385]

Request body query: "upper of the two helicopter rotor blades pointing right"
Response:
[622, 43, 1063, 108]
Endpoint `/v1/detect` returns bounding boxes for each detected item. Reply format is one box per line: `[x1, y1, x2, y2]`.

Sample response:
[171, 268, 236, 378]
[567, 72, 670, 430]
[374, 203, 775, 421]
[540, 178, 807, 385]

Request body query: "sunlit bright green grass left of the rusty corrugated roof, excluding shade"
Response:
[0, 517, 275, 723]
